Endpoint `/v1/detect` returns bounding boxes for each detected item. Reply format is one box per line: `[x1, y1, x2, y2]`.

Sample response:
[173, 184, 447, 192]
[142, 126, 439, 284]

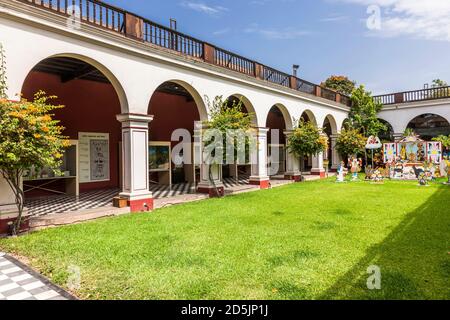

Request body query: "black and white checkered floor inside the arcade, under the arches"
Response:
[25, 176, 253, 216]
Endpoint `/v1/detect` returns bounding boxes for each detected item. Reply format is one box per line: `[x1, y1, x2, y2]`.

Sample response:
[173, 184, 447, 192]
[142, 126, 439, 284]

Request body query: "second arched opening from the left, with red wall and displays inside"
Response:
[148, 80, 206, 198]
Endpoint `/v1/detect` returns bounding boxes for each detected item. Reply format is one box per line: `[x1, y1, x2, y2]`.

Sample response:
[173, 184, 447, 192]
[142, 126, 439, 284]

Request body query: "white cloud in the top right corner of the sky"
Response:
[339, 0, 450, 41]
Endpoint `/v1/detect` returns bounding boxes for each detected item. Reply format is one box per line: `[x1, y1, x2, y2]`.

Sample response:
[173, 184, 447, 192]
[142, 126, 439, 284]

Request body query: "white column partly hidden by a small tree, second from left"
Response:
[194, 121, 224, 197]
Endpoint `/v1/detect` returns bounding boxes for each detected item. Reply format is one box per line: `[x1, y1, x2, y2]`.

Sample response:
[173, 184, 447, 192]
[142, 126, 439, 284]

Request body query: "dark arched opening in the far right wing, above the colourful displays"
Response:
[407, 113, 450, 141]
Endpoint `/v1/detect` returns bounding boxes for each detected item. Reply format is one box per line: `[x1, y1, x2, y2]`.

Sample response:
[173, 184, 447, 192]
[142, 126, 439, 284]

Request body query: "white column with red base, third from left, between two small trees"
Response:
[250, 128, 270, 189]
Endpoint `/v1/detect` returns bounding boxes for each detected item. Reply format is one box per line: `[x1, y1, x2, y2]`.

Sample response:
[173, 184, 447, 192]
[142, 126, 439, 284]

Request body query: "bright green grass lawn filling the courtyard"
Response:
[0, 180, 450, 299]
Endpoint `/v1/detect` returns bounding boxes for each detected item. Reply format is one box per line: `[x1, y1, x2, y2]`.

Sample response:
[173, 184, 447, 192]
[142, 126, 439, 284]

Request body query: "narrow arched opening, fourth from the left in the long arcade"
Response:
[266, 105, 292, 179]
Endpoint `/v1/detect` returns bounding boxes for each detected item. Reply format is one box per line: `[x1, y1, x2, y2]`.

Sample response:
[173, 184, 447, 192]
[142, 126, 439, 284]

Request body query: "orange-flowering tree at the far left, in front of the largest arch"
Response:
[0, 86, 69, 235]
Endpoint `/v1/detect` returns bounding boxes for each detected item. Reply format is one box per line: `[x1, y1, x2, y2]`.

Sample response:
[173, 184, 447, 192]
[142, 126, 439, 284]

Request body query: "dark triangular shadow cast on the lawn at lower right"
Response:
[319, 186, 450, 300]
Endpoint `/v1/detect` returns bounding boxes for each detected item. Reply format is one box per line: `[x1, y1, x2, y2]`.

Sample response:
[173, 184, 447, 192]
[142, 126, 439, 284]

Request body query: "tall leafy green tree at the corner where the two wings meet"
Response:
[347, 85, 388, 137]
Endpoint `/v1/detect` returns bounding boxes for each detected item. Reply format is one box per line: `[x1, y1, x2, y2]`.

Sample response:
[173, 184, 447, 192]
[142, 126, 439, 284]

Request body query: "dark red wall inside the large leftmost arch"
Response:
[22, 71, 121, 191]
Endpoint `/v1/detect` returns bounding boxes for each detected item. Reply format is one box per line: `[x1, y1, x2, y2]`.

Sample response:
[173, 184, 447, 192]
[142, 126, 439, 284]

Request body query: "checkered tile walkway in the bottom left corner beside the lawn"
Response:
[0, 252, 75, 300]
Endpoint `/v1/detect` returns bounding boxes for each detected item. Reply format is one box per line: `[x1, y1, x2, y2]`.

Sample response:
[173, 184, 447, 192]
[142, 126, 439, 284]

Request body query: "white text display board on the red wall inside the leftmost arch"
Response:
[78, 132, 110, 183]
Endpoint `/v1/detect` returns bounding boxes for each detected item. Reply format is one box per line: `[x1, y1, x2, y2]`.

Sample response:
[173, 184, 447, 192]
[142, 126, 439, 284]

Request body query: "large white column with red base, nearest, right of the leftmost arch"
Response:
[117, 114, 153, 212]
